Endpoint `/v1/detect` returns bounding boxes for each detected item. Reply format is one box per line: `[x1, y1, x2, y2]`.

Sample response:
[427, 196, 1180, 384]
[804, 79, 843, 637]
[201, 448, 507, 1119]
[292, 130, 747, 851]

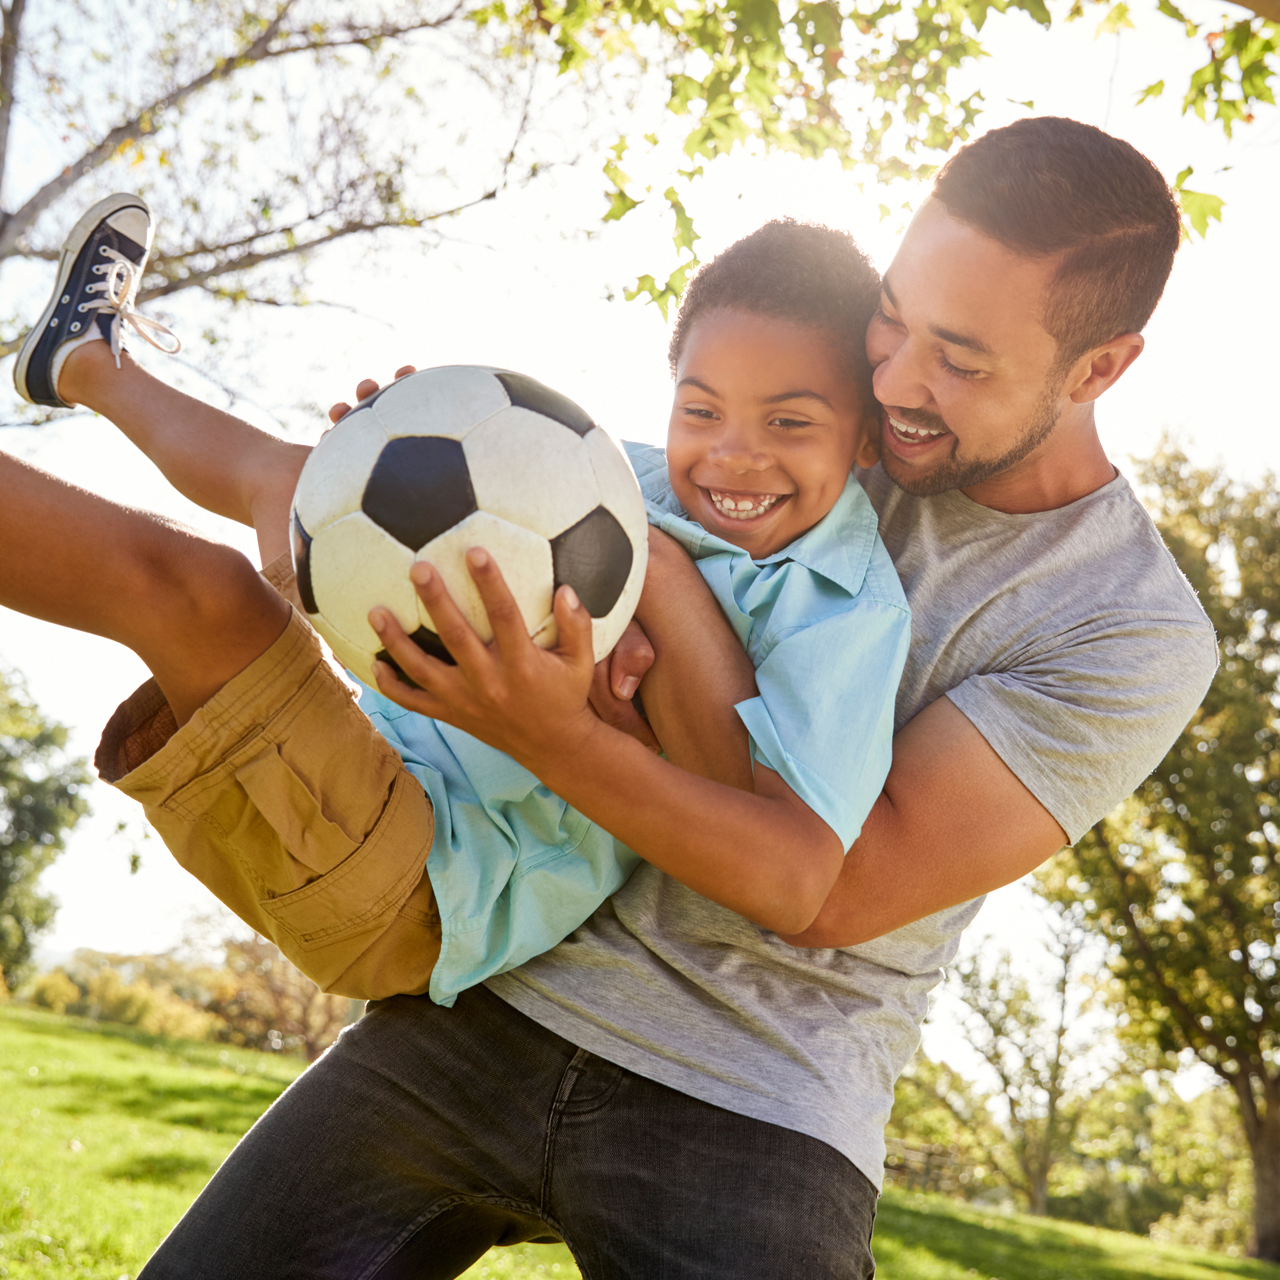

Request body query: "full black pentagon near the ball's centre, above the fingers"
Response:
[360, 435, 476, 552]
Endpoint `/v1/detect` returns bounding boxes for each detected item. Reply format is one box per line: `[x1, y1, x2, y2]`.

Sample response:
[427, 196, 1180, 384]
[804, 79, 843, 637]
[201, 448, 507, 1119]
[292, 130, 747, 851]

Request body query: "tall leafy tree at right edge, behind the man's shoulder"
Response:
[1043, 447, 1280, 1261]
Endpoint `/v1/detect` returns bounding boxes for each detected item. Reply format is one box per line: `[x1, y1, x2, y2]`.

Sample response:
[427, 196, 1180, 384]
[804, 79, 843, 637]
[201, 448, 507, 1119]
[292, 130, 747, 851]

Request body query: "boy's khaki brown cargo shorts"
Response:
[95, 557, 440, 1000]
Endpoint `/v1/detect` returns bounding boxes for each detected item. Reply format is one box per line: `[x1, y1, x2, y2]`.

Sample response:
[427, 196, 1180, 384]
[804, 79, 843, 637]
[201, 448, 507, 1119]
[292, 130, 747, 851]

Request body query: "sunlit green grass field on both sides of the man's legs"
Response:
[0, 1005, 1280, 1280]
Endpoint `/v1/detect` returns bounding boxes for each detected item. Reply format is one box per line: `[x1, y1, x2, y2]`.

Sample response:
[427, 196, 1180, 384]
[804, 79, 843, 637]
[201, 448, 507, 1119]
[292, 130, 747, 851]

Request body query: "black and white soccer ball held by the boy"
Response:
[291, 365, 649, 684]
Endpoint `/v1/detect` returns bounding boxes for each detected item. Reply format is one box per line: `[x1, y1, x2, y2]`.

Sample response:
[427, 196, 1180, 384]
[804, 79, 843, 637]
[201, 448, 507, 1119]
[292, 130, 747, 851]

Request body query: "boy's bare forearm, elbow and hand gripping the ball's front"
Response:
[370, 552, 844, 933]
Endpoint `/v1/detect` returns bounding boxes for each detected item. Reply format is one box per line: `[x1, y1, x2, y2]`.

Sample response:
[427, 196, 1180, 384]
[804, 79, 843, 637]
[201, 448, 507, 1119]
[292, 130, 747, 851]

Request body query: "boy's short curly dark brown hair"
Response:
[667, 218, 879, 407]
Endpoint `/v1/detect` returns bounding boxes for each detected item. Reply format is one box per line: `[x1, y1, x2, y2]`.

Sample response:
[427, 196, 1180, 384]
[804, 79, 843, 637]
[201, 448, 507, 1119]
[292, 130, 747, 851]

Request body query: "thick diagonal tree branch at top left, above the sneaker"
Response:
[0, 0, 461, 259]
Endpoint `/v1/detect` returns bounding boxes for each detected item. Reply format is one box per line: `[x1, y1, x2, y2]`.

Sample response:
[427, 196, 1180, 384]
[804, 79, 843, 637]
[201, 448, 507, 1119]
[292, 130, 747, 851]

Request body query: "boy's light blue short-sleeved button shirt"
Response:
[360, 444, 910, 1005]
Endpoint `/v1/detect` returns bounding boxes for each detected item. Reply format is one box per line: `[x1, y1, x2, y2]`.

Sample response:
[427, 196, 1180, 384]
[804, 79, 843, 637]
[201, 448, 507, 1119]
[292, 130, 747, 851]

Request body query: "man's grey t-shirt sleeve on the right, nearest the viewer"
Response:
[946, 617, 1217, 845]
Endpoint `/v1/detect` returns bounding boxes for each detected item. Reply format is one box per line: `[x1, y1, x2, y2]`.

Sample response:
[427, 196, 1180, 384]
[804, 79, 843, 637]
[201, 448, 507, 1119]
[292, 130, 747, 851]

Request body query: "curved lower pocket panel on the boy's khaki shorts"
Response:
[260, 772, 435, 964]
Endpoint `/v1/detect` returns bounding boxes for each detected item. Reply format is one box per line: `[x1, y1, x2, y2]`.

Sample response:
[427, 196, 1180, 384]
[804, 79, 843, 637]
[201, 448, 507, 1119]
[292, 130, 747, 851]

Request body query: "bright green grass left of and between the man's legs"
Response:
[0, 1005, 577, 1280]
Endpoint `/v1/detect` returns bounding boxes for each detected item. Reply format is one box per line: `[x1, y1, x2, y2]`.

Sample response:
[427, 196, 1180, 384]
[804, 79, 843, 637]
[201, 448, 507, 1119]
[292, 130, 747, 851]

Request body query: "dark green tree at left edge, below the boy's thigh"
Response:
[0, 671, 88, 988]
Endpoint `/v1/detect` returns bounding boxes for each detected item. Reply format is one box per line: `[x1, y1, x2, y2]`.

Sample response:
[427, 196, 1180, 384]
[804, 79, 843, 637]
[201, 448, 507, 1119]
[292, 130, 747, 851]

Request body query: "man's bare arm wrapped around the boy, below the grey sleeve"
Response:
[622, 535, 1066, 947]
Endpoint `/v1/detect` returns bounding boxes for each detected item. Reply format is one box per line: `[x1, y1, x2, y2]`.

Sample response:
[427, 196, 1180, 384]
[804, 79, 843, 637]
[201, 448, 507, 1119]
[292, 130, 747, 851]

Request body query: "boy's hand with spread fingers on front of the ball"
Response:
[369, 547, 599, 772]
